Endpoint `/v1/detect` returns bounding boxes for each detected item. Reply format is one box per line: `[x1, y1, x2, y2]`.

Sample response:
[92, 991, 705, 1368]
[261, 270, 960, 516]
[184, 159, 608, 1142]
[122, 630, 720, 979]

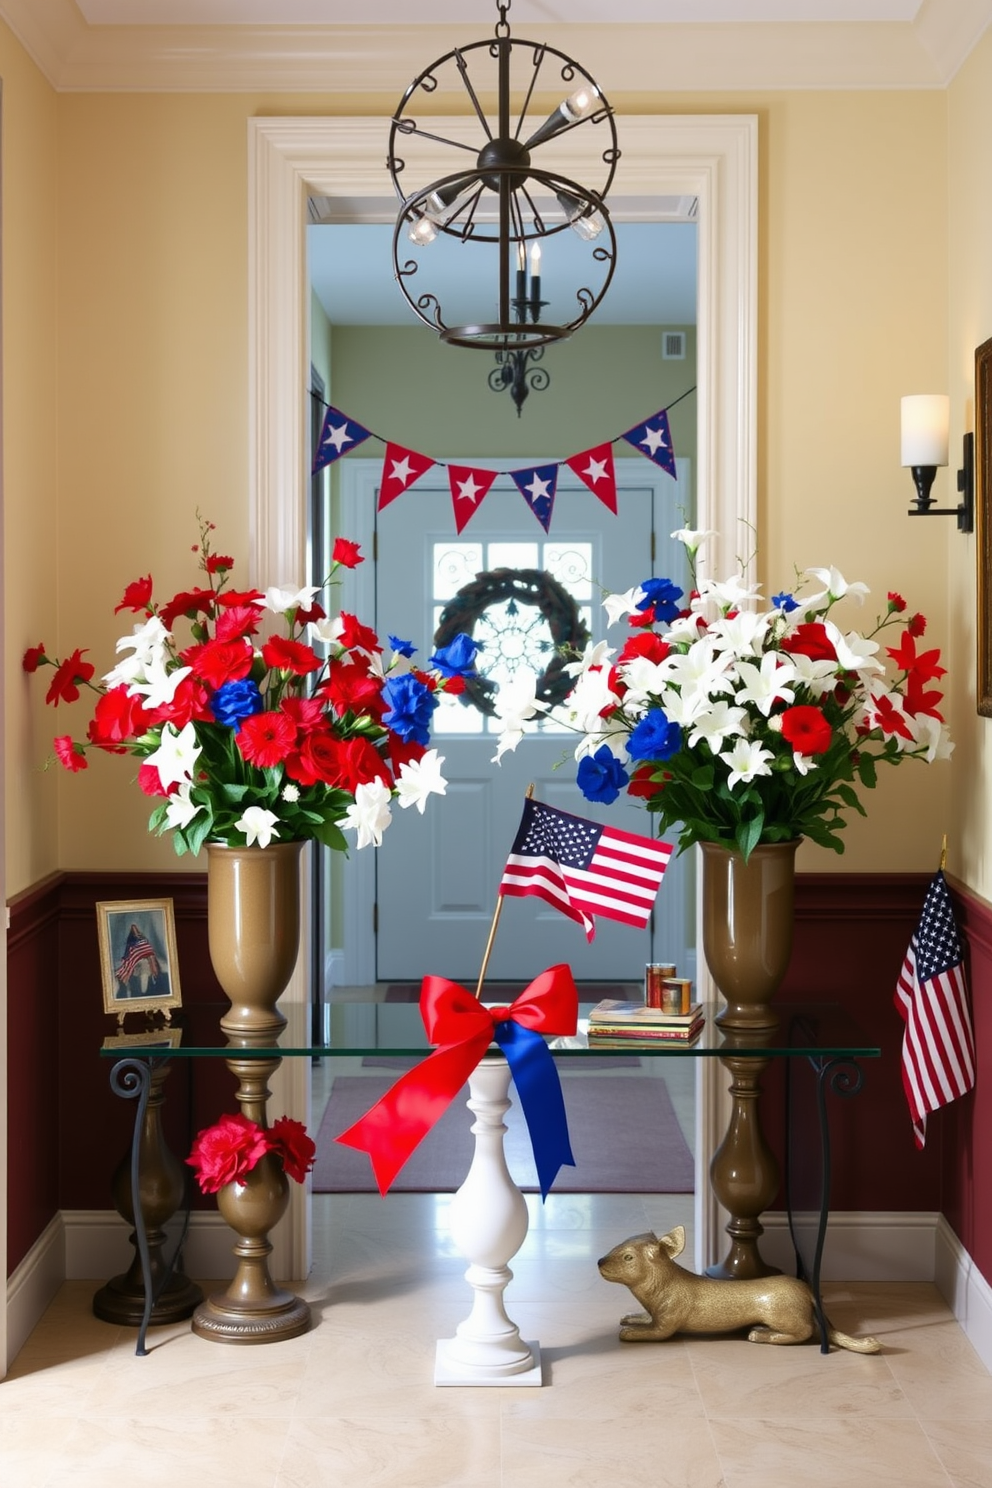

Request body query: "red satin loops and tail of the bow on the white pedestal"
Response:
[335, 964, 579, 1195]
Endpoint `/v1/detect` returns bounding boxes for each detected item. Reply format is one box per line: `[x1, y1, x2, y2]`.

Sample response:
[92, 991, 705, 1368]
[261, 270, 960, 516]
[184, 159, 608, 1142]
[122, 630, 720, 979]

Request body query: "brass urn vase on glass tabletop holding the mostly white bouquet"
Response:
[699, 839, 799, 1033]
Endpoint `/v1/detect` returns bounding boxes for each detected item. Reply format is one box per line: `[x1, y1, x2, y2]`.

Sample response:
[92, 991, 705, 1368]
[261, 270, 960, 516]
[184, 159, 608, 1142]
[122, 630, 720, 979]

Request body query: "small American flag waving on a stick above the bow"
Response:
[500, 799, 672, 940]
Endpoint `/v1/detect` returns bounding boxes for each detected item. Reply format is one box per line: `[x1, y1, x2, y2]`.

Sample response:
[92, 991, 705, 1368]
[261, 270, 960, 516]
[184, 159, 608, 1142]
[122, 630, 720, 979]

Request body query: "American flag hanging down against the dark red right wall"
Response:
[895, 872, 974, 1147]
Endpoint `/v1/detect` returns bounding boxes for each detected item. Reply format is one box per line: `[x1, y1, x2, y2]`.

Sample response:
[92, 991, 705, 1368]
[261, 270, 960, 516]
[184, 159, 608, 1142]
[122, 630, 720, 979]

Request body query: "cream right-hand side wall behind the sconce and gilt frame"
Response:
[947, 33, 992, 899]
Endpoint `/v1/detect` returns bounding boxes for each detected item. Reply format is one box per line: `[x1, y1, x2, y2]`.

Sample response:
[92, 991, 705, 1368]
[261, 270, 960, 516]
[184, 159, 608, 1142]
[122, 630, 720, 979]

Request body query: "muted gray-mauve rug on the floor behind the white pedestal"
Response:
[314, 1074, 695, 1193]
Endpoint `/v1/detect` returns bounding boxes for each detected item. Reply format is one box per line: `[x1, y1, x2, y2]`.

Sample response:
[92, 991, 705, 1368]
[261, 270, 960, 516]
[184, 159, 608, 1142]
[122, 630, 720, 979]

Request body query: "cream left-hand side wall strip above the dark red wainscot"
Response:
[0, 25, 61, 893]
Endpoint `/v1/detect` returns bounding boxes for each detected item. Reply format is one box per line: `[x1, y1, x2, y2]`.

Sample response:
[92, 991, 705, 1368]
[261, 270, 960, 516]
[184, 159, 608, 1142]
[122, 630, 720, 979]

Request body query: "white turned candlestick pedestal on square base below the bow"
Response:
[434, 1054, 541, 1388]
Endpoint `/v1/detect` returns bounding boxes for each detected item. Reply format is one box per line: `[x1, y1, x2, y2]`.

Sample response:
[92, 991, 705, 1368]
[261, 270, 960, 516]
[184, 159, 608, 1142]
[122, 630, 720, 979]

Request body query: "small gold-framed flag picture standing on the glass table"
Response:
[97, 899, 183, 1021]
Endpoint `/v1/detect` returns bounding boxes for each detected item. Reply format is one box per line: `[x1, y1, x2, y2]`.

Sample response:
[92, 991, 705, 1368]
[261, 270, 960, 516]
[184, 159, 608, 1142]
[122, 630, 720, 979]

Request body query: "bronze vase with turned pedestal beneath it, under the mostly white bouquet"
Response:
[699, 841, 799, 1280]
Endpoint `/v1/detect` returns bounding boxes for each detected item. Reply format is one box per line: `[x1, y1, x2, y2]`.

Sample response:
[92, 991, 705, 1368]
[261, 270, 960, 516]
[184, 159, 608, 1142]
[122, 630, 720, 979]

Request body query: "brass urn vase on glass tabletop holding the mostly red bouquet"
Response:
[207, 842, 303, 1037]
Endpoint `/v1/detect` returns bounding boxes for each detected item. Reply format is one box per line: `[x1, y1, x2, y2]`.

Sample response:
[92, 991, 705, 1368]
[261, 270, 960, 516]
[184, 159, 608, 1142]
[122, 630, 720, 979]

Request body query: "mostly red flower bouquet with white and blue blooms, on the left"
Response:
[22, 521, 476, 854]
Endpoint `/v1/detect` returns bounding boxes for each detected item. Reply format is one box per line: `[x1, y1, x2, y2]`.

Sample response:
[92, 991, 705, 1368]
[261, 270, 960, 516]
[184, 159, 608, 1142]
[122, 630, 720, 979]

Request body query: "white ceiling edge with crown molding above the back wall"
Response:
[0, 0, 992, 90]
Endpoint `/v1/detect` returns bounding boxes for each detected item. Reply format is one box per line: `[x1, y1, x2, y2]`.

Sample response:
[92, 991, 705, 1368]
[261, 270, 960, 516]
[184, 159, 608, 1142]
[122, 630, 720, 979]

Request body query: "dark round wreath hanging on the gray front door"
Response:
[434, 568, 589, 717]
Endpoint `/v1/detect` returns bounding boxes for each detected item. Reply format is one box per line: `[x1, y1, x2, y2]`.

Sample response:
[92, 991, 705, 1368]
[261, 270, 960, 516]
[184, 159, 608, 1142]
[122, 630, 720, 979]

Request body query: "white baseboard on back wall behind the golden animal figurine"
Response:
[761, 1210, 938, 1281]
